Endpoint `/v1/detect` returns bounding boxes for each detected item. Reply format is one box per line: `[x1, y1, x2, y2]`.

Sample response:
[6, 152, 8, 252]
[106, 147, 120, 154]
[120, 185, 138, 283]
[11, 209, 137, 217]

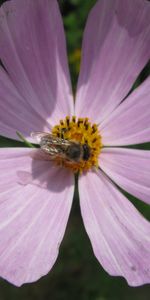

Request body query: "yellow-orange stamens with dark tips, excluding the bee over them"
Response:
[52, 116, 102, 173]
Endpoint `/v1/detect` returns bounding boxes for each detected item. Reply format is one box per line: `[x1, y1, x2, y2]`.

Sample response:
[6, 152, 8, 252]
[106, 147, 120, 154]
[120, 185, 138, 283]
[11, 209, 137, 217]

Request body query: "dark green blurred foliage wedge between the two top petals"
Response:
[59, 0, 96, 91]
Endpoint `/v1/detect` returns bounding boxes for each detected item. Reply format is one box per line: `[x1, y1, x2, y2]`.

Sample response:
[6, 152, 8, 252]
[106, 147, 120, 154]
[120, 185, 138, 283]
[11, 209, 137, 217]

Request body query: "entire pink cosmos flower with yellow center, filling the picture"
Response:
[0, 0, 150, 286]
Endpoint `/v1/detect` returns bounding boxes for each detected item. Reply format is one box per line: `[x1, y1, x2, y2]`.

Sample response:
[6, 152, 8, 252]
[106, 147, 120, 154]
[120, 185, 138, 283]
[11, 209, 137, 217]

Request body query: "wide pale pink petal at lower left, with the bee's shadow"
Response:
[0, 148, 74, 286]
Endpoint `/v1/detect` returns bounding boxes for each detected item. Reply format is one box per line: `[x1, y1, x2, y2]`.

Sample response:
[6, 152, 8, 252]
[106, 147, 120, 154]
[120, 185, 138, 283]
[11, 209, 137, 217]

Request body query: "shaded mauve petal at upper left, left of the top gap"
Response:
[0, 0, 73, 141]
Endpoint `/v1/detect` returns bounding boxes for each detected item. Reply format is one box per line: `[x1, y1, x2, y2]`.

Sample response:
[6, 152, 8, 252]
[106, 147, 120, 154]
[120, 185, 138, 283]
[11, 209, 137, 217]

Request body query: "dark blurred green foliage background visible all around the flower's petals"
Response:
[0, 0, 150, 300]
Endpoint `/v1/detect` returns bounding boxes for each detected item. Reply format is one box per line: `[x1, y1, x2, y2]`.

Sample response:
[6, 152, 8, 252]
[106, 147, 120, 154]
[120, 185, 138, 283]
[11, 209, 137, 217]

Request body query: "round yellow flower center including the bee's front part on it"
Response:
[52, 116, 102, 173]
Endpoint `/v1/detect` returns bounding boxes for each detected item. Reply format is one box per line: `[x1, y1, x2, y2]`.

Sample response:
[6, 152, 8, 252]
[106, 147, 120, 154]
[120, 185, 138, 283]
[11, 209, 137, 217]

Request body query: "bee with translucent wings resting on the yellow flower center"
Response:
[31, 132, 91, 163]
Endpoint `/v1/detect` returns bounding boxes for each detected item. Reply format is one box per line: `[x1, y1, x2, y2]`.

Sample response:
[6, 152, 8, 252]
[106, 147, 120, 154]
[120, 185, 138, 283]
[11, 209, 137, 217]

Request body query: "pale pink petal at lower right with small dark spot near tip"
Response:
[79, 172, 150, 286]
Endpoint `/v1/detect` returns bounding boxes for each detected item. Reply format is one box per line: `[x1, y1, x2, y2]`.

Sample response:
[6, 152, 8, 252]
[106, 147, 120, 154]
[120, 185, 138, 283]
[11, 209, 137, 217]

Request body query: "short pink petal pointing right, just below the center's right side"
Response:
[99, 148, 150, 204]
